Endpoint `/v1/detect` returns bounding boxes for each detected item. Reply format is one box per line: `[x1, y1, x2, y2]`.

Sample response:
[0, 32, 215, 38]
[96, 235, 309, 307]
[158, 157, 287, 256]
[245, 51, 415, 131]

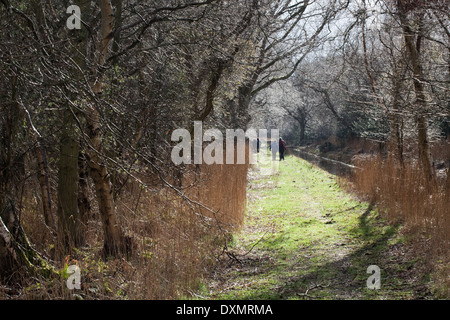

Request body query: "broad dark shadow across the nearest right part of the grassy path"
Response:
[232, 204, 398, 300]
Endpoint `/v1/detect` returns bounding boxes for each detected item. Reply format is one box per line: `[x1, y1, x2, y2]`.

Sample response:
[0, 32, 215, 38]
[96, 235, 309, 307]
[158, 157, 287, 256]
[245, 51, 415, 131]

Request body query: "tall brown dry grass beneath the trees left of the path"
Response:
[0, 145, 248, 300]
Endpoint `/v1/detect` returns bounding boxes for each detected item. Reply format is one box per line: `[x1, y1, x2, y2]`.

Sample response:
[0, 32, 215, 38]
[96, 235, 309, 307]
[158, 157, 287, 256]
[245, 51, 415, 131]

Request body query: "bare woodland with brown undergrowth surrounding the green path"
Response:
[0, 0, 450, 299]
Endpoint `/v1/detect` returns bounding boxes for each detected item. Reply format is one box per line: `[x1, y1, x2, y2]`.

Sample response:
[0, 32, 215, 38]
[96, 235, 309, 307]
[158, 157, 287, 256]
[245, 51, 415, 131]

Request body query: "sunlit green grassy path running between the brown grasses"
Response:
[206, 155, 430, 299]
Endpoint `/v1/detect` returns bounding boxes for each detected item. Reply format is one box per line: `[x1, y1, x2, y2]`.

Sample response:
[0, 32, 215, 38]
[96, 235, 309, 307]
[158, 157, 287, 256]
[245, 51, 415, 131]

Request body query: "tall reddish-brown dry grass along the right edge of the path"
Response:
[351, 156, 450, 296]
